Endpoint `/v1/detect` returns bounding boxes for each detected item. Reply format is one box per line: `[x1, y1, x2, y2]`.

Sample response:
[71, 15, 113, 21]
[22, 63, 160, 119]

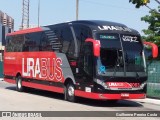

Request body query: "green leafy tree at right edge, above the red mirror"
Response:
[141, 6, 160, 47]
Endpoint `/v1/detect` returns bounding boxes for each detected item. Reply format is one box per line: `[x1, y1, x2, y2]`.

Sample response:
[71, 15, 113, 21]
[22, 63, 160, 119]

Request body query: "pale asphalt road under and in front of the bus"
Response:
[0, 81, 160, 120]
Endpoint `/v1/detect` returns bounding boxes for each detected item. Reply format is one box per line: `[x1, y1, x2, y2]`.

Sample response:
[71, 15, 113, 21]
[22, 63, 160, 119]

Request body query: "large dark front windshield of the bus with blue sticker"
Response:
[96, 33, 145, 77]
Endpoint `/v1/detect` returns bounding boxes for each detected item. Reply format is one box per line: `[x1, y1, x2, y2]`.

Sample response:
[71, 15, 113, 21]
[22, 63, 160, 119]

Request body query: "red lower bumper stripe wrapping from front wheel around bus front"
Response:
[75, 90, 146, 100]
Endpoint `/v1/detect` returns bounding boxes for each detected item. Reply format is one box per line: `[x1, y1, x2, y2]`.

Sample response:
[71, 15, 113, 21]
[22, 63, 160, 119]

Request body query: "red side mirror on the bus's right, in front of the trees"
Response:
[143, 42, 158, 58]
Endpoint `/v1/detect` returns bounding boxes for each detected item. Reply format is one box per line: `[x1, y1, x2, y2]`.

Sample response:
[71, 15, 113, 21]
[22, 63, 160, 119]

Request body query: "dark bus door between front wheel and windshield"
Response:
[76, 42, 94, 92]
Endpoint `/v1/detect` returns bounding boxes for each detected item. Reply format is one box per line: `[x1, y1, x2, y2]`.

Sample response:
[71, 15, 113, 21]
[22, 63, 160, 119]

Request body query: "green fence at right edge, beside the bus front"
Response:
[147, 60, 160, 98]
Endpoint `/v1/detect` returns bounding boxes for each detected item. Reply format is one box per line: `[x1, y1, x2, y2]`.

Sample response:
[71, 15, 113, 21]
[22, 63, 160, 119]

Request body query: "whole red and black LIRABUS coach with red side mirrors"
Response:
[4, 20, 158, 102]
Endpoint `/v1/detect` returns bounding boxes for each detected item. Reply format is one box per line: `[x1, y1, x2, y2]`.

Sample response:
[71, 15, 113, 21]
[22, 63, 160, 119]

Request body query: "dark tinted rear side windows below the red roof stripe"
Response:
[6, 32, 42, 52]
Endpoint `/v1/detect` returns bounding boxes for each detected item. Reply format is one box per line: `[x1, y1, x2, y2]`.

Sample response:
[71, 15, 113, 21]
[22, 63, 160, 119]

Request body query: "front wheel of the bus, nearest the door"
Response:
[64, 82, 76, 102]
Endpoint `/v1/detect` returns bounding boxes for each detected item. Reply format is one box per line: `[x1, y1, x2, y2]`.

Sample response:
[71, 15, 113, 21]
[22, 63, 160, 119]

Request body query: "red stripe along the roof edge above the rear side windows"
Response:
[7, 27, 42, 36]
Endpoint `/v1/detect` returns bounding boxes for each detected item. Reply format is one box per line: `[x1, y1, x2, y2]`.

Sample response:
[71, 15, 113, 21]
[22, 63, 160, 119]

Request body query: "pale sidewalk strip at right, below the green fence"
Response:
[132, 98, 160, 105]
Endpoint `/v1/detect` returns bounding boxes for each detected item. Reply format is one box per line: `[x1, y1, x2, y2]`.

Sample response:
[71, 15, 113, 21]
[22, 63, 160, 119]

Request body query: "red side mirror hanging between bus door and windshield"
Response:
[85, 38, 100, 57]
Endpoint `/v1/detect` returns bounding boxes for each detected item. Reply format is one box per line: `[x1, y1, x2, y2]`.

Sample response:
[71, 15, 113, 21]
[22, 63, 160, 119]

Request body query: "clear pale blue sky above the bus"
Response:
[0, 0, 158, 35]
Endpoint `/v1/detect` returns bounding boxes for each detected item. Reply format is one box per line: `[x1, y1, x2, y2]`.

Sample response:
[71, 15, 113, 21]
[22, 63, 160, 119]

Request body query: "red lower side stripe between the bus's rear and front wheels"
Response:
[22, 81, 63, 93]
